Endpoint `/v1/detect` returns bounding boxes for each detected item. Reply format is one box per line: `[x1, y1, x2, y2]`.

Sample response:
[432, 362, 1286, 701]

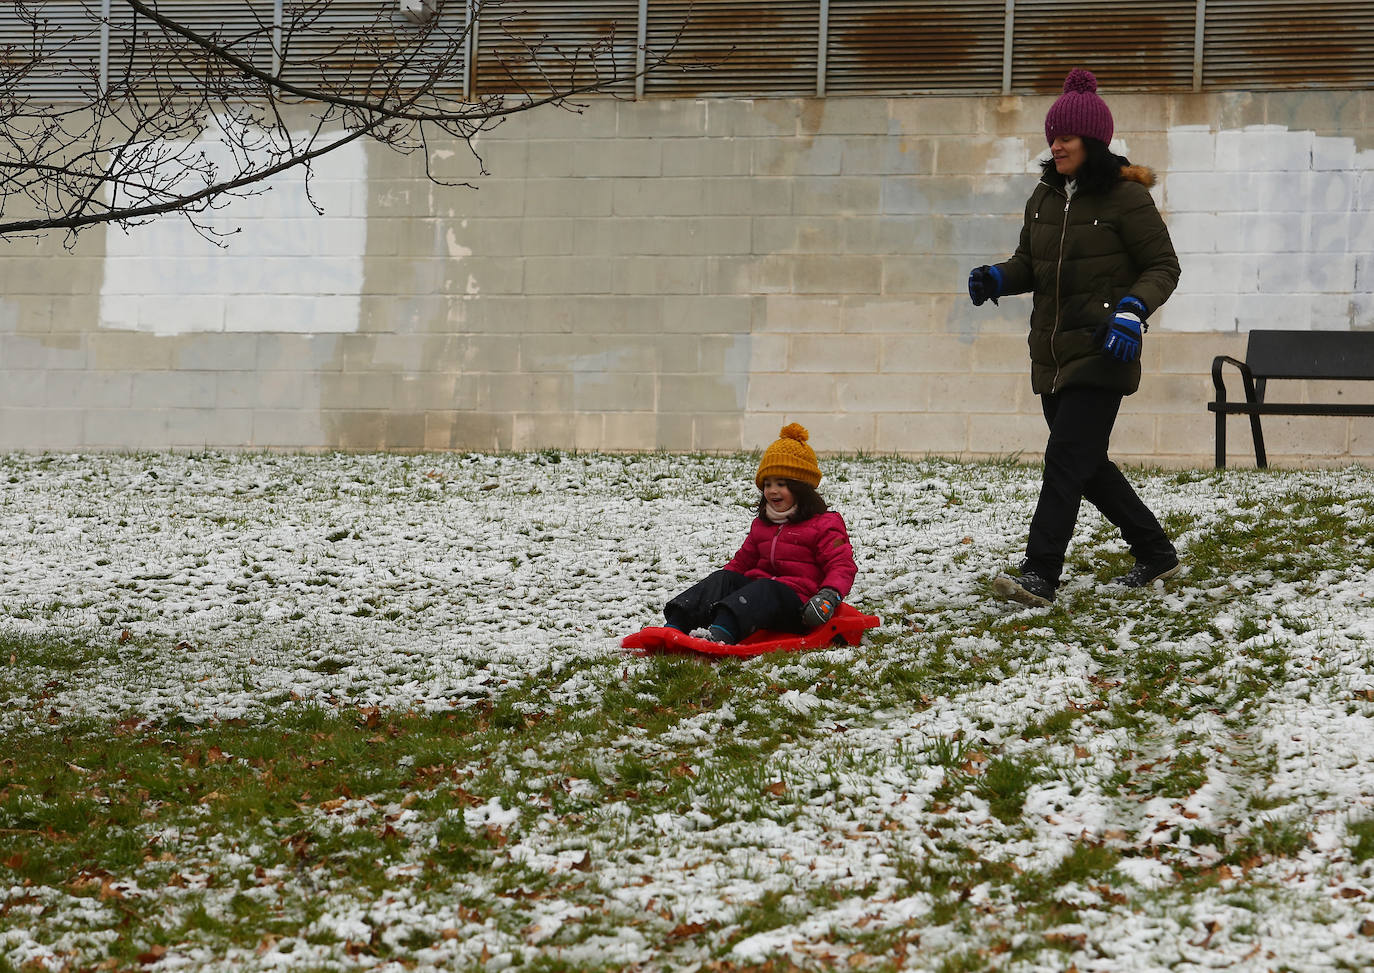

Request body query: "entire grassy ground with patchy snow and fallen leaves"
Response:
[0, 452, 1374, 973]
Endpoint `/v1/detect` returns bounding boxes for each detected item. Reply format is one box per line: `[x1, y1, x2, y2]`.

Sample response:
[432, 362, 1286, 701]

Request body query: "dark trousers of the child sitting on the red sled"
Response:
[664, 569, 807, 640]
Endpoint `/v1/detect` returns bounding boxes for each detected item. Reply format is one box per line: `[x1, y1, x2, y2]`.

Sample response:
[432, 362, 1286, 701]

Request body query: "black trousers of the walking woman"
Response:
[1025, 388, 1176, 584]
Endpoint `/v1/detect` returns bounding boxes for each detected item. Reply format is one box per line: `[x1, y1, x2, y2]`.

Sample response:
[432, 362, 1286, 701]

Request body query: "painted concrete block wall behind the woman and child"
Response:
[0, 92, 1374, 466]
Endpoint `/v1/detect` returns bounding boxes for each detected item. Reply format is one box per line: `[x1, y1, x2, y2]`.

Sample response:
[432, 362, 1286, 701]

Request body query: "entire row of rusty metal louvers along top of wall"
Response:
[0, 0, 1374, 100]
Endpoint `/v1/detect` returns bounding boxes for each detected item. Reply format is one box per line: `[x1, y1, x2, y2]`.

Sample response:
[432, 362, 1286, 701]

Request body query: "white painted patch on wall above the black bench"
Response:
[1160, 125, 1374, 331]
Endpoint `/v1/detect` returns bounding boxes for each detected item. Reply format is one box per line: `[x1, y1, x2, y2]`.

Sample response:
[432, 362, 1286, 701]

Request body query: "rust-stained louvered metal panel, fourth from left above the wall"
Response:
[474, 0, 639, 96]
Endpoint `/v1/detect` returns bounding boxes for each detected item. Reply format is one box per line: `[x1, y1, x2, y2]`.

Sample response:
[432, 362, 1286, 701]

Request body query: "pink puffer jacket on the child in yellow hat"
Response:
[725, 510, 859, 601]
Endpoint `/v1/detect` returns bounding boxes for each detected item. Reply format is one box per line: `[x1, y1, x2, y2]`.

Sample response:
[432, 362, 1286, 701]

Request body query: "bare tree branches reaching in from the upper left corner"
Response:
[0, 0, 692, 246]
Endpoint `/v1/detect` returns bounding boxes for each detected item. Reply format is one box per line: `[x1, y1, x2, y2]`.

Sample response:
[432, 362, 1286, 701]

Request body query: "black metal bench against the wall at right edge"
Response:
[1206, 331, 1374, 470]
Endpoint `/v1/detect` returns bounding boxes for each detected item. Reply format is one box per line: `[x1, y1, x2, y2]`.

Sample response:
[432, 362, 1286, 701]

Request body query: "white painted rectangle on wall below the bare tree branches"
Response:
[100, 127, 367, 335]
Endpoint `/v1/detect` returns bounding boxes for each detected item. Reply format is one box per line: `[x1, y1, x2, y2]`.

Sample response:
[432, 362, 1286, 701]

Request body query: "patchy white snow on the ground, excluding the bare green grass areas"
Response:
[0, 454, 1374, 972]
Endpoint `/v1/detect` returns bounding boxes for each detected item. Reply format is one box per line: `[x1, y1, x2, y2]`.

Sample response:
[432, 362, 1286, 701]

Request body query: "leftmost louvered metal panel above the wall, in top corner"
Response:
[0, 0, 100, 102]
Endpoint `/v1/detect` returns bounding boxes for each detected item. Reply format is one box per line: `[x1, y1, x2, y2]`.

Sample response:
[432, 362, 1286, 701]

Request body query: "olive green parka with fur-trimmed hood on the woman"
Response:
[998, 165, 1179, 396]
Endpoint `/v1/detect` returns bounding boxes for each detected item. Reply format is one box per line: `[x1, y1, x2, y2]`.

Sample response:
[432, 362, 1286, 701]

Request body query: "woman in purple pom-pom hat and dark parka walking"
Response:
[969, 70, 1179, 605]
